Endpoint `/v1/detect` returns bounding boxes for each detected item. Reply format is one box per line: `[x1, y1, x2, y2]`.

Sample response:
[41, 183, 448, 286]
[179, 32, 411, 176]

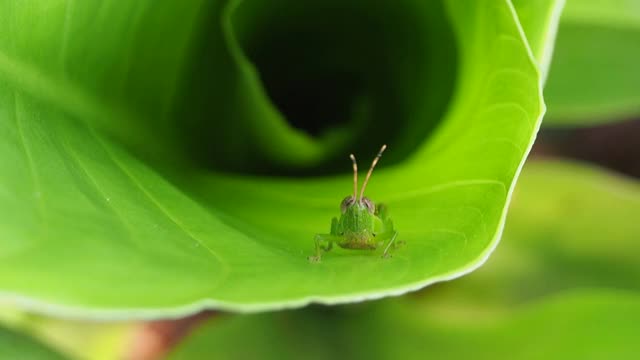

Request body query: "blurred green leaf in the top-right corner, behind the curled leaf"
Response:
[545, 0, 640, 126]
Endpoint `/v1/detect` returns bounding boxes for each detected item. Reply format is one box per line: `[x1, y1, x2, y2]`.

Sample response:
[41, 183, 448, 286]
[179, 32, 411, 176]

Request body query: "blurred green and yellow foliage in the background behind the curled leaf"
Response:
[0, 0, 640, 359]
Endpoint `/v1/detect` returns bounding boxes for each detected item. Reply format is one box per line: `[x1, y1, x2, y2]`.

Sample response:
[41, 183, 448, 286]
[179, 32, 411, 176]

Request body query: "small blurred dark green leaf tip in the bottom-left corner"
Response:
[0, 327, 65, 360]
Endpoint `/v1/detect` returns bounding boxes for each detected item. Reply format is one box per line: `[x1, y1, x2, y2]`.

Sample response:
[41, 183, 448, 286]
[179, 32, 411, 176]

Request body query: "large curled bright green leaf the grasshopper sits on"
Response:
[0, 0, 547, 318]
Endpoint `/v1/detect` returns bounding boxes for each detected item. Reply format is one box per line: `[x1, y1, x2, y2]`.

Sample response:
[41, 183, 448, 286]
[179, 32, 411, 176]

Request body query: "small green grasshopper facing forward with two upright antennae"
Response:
[308, 145, 398, 262]
